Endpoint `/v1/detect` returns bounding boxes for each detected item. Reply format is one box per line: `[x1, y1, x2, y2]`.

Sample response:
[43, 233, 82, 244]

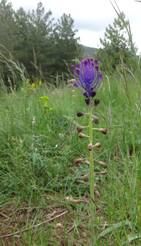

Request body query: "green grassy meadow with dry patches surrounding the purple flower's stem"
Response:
[0, 77, 141, 246]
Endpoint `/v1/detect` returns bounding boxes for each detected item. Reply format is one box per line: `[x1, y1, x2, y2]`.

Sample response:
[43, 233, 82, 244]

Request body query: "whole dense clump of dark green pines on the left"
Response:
[0, 0, 80, 86]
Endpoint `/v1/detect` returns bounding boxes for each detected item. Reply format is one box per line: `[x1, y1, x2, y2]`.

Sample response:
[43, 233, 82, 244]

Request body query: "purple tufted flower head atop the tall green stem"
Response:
[72, 58, 102, 100]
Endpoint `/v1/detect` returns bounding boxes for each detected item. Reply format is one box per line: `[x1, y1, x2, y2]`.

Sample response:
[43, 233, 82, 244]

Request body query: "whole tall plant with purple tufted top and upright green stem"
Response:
[71, 58, 107, 239]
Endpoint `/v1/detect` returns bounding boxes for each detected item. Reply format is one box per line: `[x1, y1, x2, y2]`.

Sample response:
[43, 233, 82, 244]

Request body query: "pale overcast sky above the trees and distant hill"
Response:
[9, 0, 141, 52]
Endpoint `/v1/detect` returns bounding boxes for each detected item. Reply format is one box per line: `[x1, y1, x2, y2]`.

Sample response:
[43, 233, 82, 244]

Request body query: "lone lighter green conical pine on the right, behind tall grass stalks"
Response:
[97, 12, 135, 71]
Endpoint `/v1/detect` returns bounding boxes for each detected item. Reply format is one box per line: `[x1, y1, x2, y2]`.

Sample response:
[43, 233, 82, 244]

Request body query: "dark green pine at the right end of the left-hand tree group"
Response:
[51, 14, 80, 75]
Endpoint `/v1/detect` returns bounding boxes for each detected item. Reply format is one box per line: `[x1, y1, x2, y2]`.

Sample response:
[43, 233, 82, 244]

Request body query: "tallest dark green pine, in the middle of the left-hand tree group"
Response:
[15, 3, 52, 78]
